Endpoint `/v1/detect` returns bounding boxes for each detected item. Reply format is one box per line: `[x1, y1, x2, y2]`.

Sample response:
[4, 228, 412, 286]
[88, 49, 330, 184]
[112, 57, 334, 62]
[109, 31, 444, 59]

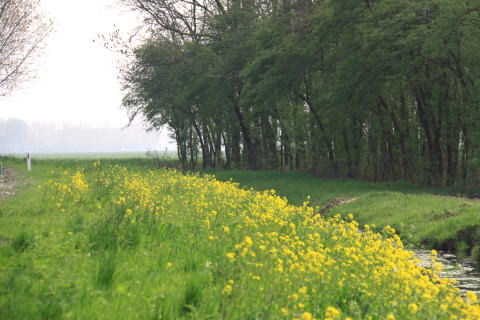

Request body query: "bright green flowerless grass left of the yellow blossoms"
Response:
[0, 157, 191, 319]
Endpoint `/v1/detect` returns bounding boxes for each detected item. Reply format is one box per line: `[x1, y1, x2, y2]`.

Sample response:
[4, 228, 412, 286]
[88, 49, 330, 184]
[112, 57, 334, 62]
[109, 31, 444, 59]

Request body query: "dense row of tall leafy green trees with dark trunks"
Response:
[123, 0, 480, 185]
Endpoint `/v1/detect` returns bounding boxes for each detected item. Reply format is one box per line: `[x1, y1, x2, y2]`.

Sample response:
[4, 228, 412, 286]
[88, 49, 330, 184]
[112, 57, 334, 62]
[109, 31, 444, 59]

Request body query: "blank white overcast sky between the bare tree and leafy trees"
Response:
[0, 0, 171, 151]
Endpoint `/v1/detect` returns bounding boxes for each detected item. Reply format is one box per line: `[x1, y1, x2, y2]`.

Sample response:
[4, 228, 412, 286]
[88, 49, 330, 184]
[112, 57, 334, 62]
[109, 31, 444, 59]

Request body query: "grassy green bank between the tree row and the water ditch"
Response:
[205, 170, 480, 254]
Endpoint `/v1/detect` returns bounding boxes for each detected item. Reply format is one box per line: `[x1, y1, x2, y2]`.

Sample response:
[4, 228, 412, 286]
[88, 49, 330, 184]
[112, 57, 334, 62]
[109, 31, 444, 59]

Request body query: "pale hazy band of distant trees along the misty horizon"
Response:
[0, 118, 172, 154]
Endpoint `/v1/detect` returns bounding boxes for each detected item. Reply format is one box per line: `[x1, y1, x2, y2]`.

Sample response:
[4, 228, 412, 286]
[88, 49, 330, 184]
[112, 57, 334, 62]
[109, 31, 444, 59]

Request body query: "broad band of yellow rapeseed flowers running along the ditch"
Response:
[42, 164, 480, 319]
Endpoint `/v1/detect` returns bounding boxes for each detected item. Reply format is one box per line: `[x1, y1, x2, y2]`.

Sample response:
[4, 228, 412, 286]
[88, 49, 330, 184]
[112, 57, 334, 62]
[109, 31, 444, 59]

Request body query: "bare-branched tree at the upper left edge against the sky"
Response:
[0, 0, 52, 95]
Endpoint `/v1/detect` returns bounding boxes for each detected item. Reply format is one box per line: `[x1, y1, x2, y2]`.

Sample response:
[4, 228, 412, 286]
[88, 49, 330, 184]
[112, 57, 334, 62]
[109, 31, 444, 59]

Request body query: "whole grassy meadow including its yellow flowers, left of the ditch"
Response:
[0, 160, 480, 320]
